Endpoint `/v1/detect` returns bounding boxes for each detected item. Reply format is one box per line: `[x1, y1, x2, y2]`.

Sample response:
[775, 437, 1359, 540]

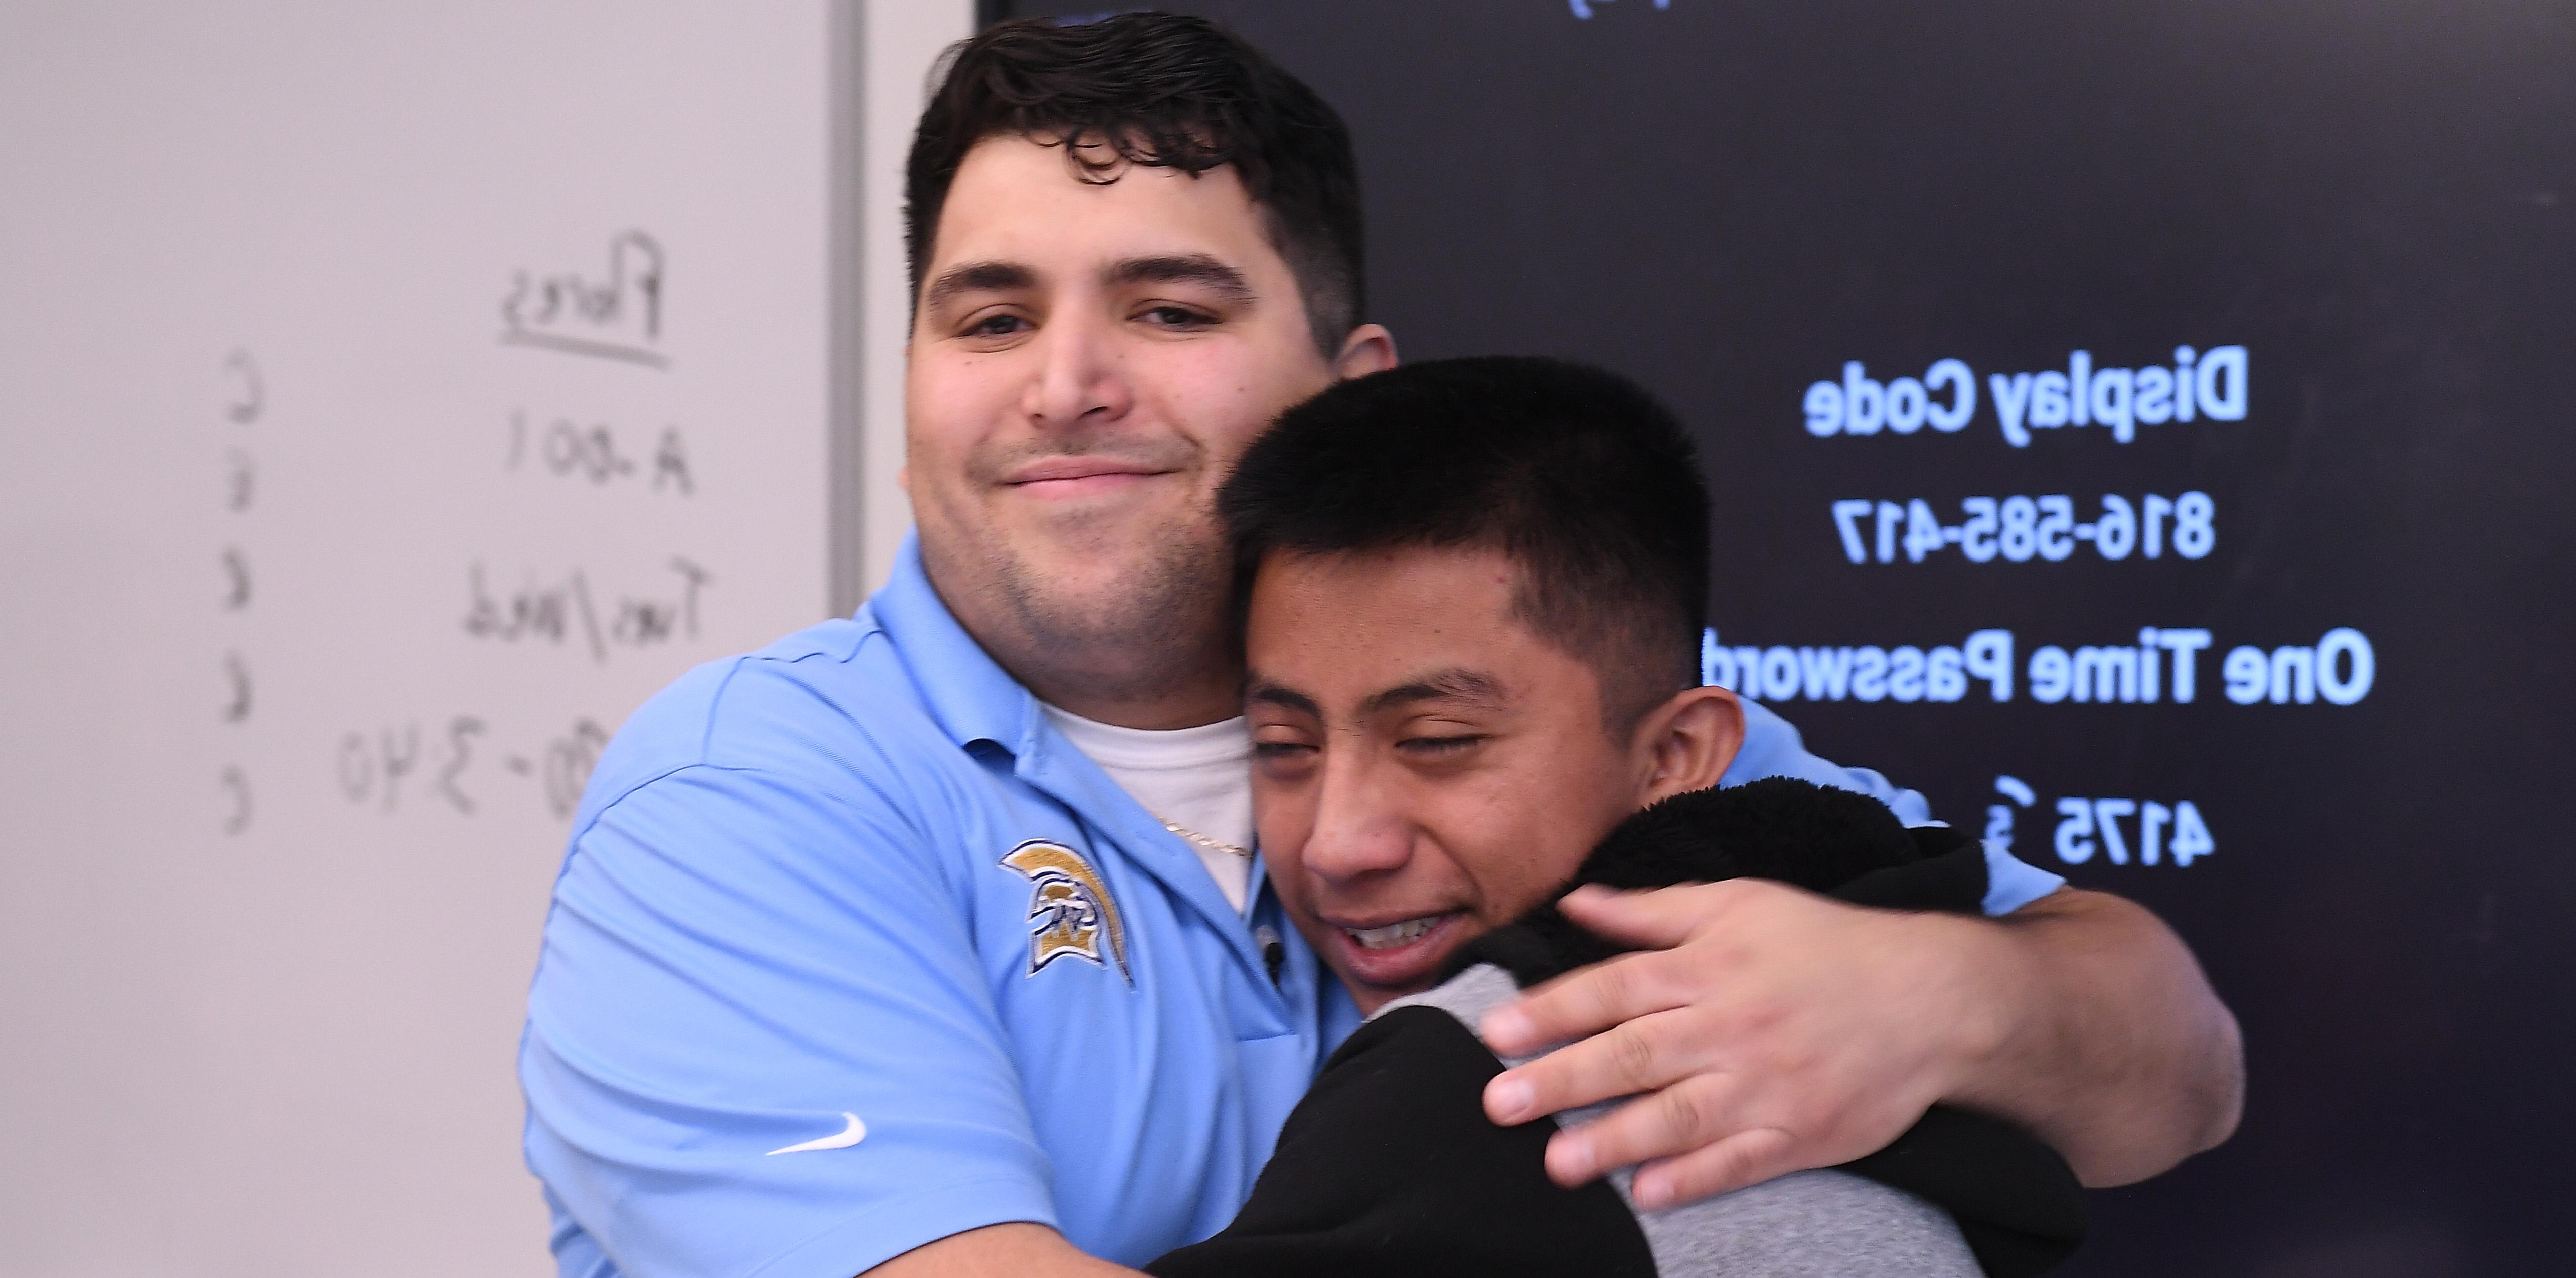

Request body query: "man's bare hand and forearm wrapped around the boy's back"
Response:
[1484, 878, 2244, 1209]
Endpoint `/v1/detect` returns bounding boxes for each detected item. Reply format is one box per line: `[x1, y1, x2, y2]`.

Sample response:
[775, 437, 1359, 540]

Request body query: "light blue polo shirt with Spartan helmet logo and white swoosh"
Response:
[520, 538, 2056, 1278]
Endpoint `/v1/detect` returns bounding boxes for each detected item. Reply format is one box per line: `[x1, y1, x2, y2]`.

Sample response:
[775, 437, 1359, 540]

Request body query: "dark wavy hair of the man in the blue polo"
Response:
[904, 13, 1368, 358]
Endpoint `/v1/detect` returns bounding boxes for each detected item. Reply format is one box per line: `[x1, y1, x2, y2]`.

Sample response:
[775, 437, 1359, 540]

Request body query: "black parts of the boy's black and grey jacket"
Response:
[1146, 778, 2084, 1278]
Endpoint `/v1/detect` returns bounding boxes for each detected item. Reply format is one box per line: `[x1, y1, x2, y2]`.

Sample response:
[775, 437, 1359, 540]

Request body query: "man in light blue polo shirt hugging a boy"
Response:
[520, 13, 2236, 1278]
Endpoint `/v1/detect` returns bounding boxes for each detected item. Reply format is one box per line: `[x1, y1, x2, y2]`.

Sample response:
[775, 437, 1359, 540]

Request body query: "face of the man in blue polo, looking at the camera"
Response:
[904, 136, 1391, 727]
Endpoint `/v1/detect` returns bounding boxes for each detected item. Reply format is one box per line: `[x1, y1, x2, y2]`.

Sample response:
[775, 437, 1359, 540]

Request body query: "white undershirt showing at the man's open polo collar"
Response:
[1038, 701, 1254, 915]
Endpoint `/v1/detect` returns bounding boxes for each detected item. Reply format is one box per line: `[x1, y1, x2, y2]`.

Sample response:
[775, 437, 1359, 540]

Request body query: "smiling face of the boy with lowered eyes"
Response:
[1244, 549, 1651, 1013]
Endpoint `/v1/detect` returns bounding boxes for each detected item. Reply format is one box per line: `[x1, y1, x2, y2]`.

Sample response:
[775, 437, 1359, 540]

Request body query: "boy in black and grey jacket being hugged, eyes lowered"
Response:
[1146, 358, 2084, 1278]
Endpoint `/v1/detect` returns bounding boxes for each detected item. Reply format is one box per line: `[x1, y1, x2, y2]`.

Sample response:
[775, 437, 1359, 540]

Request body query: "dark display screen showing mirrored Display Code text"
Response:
[1002, 0, 2576, 1275]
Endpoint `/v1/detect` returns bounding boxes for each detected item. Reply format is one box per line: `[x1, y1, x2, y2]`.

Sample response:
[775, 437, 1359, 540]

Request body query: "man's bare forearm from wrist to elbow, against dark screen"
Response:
[1948, 889, 2244, 1188]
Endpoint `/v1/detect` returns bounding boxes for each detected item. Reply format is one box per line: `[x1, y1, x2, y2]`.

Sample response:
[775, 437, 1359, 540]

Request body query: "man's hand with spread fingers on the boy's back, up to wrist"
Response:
[1484, 878, 1994, 1209]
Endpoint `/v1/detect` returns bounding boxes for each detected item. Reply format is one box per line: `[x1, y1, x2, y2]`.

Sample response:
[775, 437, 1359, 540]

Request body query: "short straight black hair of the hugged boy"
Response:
[1216, 356, 1708, 732]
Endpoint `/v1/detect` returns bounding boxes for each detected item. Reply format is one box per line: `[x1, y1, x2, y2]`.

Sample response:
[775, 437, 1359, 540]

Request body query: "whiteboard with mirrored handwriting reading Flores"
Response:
[0, 0, 896, 1275]
